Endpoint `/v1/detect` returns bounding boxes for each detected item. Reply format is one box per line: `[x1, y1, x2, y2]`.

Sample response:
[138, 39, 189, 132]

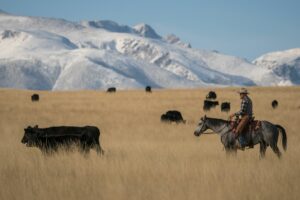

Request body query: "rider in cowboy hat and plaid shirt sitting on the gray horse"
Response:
[230, 88, 253, 149]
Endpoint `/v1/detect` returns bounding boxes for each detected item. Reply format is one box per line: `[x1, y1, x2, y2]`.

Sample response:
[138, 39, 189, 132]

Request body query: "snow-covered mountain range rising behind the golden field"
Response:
[0, 11, 300, 90]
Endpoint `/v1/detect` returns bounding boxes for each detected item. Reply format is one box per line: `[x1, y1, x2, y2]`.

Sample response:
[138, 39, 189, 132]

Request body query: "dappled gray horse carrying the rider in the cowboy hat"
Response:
[194, 116, 287, 158]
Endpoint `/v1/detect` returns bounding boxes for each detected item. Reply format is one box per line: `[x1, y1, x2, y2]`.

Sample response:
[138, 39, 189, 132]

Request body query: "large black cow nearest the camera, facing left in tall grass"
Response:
[21, 126, 104, 154]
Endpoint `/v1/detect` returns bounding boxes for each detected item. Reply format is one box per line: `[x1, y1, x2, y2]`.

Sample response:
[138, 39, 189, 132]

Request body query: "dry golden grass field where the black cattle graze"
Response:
[0, 87, 300, 200]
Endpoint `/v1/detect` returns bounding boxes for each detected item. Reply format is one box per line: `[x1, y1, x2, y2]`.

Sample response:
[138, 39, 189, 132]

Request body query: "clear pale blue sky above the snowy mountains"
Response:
[0, 0, 300, 60]
